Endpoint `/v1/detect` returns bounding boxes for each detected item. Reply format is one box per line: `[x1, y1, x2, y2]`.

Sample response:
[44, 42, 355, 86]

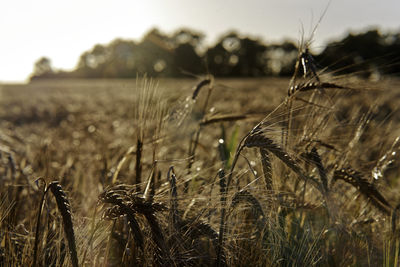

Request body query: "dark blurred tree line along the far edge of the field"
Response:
[31, 28, 400, 80]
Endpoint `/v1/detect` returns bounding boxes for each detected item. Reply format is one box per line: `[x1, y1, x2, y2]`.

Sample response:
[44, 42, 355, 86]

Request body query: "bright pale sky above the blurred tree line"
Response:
[0, 0, 400, 82]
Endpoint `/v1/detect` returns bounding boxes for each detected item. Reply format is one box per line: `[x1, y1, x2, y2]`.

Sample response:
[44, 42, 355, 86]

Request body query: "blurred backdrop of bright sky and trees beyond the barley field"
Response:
[0, 0, 400, 83]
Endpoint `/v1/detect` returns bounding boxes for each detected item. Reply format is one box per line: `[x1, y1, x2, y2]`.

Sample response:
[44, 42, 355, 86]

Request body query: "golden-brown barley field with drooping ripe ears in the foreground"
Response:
[0, 75, 400, 266]
